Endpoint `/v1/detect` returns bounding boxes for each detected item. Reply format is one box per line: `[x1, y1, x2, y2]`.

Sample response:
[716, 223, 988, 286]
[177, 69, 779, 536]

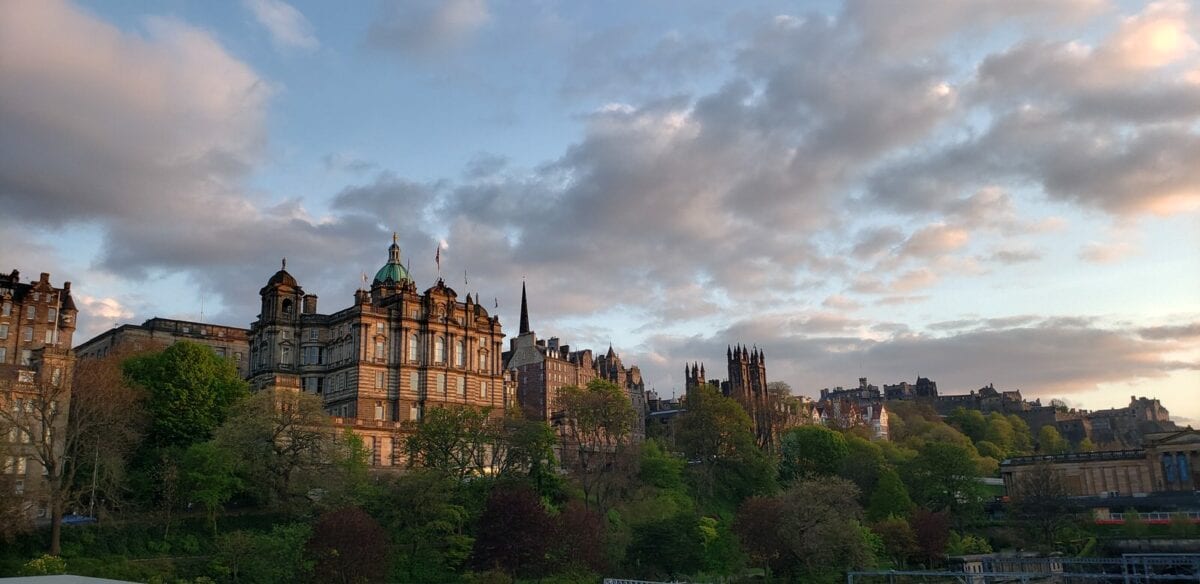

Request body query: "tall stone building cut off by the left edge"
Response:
[0, 270, 78, 517]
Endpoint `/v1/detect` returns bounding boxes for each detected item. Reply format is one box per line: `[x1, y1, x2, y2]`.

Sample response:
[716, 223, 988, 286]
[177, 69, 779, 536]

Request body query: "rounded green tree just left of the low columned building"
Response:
[910, 442, 984, 522]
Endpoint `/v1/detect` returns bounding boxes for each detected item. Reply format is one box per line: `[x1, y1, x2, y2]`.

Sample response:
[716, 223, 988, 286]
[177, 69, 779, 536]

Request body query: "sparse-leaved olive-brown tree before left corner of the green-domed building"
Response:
[215, 390, 340, 505]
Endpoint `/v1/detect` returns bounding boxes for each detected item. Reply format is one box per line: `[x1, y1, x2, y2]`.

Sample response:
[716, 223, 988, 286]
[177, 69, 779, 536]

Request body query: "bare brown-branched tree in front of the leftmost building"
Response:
[0, 354, 144, 555]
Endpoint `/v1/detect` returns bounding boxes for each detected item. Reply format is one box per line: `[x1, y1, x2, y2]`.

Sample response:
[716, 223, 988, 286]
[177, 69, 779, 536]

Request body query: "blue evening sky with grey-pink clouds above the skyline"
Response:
[0, 0, 1200, 425]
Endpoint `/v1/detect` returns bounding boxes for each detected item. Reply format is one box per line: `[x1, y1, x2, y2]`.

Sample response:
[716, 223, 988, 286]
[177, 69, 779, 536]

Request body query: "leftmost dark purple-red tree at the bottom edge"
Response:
[305, 507, 390, 584]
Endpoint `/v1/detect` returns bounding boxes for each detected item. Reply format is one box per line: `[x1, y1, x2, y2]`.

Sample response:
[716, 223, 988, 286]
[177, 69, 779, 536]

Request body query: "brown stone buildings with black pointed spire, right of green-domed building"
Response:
[504, 284, 647, 440]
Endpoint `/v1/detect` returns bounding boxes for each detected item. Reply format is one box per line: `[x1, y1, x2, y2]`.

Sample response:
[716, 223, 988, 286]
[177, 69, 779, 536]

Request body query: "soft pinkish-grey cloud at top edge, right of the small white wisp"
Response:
[367, 0, 491, 56]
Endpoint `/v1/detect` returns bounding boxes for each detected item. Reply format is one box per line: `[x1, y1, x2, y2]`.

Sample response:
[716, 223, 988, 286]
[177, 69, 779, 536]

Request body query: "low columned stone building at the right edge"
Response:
[1000, 428, 1200, 498]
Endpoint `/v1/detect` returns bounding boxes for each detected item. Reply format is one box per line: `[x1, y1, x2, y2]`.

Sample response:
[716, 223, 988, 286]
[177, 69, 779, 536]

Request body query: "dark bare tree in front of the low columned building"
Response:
[1009, 463, 1074, 550]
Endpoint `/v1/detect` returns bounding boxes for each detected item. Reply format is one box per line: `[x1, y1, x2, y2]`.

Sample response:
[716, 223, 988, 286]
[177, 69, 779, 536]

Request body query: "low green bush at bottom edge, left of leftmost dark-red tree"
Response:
[212, 524, 313, 584]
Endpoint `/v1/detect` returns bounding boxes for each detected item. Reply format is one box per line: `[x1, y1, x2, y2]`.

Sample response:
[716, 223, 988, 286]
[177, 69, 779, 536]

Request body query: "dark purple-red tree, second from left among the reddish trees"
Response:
[472, 484, 554, 578]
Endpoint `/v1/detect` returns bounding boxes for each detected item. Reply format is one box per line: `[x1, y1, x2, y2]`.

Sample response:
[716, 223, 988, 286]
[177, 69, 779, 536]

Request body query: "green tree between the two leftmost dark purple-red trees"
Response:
[367, 469, 474, 582]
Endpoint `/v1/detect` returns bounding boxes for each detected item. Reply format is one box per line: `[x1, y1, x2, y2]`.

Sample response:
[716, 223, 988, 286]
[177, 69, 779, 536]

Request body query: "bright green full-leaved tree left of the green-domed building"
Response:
[124, 341, 248, 448]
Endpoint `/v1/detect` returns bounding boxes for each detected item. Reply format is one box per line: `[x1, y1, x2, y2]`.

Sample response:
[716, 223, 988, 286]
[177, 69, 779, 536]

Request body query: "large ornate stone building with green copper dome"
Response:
[248, 236, 510, 466]
